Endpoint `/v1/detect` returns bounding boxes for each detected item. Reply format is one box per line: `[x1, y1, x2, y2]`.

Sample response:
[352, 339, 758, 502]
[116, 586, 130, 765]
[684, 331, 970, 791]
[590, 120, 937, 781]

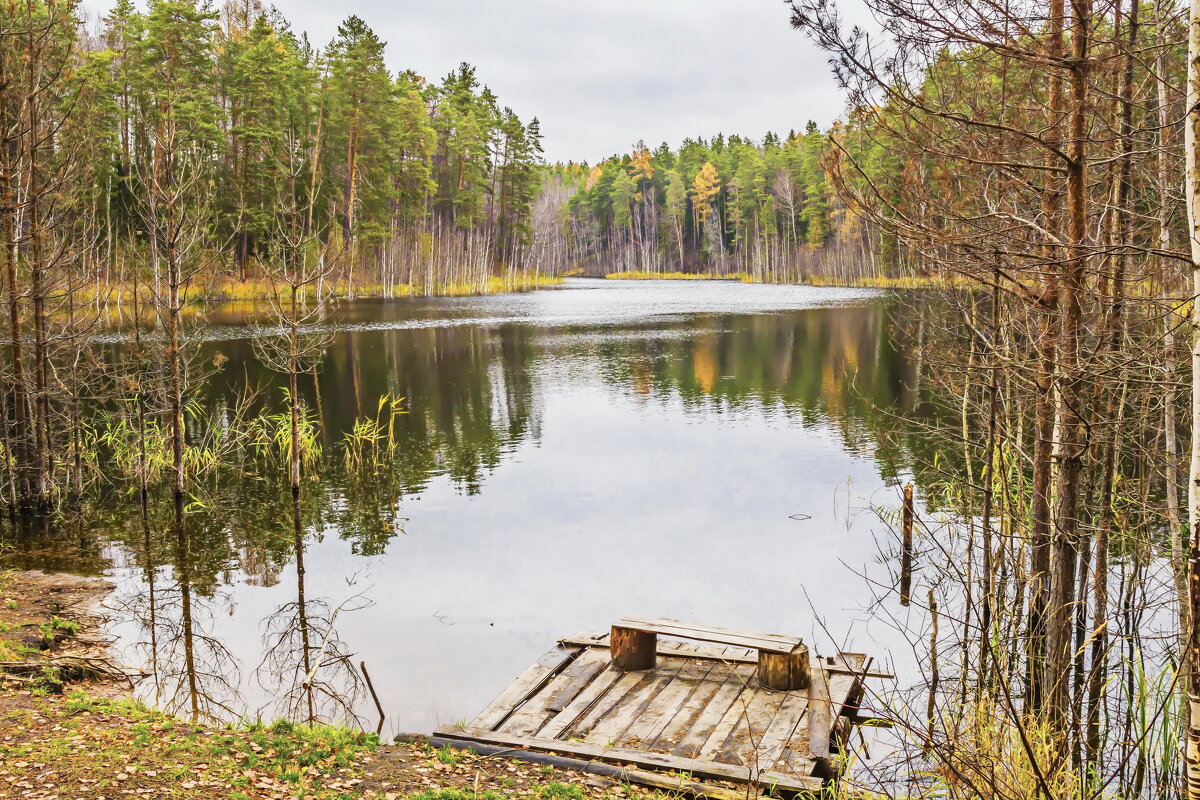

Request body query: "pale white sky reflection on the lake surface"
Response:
[103, 284, 921, 730]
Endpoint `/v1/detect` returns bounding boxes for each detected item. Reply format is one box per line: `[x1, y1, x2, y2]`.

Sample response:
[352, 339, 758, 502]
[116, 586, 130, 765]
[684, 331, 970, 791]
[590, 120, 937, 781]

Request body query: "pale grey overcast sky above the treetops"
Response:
[85, 0, 842, 162]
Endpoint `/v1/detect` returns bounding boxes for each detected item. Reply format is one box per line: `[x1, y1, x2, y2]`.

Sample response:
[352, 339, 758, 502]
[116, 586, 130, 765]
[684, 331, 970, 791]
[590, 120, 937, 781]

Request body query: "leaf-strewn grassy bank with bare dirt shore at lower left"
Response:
[0, 571, 665, 800]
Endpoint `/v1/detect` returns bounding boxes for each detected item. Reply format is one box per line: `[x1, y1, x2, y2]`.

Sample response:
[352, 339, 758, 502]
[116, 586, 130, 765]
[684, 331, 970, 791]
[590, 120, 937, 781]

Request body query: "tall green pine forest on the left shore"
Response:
[0, 0, 552, 305]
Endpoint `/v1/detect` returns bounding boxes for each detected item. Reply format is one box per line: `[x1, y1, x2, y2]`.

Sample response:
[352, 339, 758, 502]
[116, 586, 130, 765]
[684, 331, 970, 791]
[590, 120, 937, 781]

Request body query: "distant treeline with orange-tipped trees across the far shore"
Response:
[547, 121, 896, 281]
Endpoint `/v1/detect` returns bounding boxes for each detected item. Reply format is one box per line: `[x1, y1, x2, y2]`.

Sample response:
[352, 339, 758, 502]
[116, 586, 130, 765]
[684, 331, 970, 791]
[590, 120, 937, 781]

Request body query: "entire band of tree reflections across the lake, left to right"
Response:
[4, 301, 961, 575]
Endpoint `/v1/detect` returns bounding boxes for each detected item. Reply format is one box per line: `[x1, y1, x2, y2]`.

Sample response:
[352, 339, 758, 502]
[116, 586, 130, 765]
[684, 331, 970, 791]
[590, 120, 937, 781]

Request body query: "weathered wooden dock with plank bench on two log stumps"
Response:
[434, 618, 882, 798]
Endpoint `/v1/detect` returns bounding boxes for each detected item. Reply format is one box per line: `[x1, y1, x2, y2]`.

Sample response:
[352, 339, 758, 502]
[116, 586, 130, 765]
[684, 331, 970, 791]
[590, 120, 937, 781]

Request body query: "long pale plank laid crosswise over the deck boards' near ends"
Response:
[436, 727, 822, 792]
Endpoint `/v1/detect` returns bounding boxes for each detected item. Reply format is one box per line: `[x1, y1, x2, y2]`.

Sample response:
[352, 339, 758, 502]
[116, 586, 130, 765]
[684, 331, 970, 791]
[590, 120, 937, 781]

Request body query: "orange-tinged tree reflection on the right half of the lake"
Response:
[585, 302, 936, 480]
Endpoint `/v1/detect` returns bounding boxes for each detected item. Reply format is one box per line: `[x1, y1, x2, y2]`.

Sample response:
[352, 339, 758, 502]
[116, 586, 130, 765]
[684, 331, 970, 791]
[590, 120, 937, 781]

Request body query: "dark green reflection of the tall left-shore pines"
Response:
[209, 325, 538, 503]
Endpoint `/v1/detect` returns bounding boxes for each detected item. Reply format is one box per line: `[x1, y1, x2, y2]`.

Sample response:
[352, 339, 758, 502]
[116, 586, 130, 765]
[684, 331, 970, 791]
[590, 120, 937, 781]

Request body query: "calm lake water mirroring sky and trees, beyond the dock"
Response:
[2, 279, 936, 732]
